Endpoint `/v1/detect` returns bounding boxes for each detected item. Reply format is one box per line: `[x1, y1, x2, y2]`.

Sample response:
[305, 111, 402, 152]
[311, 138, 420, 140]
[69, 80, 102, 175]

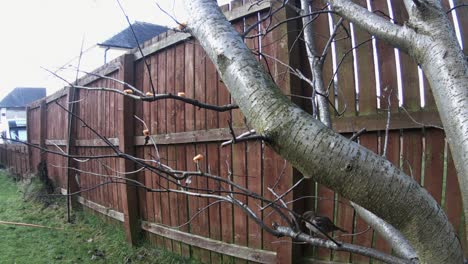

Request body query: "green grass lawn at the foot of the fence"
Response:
[0, 171, 195, 264]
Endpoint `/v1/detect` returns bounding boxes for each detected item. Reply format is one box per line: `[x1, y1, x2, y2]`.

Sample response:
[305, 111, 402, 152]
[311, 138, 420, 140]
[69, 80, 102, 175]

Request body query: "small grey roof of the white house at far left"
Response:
[0, 87, 46, 107]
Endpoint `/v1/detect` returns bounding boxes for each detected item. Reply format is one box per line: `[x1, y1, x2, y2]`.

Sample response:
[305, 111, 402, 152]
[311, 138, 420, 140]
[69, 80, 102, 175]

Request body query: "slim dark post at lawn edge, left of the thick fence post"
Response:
[66, 86, 81, 213]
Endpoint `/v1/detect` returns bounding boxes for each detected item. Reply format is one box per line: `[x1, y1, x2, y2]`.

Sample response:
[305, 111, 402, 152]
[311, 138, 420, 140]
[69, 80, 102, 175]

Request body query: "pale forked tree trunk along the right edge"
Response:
[329, 0, 468, 237]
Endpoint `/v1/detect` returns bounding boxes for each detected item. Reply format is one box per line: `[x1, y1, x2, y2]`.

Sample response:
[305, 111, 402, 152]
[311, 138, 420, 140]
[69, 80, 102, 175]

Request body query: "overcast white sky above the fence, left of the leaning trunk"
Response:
[0, 0, 228, 99]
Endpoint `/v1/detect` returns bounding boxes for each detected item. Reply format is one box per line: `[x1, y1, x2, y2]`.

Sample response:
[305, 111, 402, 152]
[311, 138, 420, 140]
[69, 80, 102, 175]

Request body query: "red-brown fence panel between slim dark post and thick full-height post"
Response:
[73, 67, 122, 212]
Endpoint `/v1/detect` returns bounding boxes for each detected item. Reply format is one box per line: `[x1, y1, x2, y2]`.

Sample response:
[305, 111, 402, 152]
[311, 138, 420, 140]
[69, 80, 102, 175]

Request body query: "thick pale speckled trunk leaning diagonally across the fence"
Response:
[185, 0, 463, 263]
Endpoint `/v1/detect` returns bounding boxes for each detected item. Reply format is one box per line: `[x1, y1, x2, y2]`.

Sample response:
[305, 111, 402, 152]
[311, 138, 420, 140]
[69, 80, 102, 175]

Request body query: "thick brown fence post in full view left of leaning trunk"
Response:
[117, 54, 141, 245]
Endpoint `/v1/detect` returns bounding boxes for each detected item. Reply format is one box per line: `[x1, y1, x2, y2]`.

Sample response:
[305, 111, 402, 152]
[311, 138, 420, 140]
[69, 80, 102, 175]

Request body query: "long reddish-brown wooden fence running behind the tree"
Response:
[0, 1, 468, 263]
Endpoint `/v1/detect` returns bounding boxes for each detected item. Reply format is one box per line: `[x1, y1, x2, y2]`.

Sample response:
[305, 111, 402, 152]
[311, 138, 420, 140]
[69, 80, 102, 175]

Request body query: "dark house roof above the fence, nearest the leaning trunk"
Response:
[98, 21, 168, 49]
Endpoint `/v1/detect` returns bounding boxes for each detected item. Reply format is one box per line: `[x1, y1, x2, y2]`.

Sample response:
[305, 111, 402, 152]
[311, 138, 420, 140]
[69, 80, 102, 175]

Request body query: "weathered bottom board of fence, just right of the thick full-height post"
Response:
[141, 221, 276, 263]
